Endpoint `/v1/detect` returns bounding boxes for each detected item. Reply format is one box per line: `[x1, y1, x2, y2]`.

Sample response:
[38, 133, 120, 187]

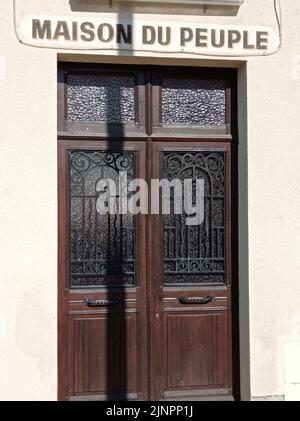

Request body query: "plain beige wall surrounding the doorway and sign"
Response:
[0, 0, 300, 400]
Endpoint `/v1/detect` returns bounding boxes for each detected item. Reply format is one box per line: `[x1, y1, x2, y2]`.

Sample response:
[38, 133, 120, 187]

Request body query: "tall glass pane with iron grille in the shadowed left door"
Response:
[70, 151, 135, 288]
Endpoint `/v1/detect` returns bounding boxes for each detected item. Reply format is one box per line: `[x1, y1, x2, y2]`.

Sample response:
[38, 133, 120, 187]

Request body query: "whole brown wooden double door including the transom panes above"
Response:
[58, 65, 236, 400]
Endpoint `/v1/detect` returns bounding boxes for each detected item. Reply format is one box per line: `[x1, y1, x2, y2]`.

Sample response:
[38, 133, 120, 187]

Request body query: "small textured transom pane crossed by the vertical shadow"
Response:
[67, 74, 135, 123]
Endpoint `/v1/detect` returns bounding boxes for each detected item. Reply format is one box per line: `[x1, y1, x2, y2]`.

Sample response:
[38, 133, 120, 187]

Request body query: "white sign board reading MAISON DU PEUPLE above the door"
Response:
[18, 14, 280, 56]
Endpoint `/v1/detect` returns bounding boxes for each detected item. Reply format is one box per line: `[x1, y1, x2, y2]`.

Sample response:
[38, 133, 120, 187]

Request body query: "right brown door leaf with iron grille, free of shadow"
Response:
[151, 142, 232, 399]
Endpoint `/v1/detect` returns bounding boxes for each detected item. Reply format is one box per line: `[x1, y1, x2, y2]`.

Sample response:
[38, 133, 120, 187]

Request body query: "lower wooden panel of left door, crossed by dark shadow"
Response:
[70, 313, 137, 398]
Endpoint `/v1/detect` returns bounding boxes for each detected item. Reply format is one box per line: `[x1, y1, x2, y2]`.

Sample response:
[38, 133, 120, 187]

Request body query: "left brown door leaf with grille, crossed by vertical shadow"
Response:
[59, 141, 147, 400]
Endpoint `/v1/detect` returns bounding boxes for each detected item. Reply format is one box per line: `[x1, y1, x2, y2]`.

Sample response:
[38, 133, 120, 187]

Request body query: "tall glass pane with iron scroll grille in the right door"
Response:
[164, 152, 226, 286]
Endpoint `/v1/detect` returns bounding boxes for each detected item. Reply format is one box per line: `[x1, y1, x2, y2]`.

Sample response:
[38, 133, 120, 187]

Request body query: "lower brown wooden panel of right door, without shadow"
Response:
[164, 309, 227, 390]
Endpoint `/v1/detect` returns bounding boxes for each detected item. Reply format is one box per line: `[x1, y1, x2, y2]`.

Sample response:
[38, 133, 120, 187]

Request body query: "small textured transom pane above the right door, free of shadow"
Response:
[162, 78, 226, 126]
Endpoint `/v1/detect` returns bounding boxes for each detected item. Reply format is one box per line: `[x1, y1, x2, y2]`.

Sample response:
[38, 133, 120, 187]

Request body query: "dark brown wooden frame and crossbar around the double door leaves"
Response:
[57, 63, 244, 400]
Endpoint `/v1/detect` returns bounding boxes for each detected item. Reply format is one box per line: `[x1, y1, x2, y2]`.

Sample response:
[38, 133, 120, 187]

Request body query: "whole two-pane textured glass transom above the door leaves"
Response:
[58, 65, 233, 139]
